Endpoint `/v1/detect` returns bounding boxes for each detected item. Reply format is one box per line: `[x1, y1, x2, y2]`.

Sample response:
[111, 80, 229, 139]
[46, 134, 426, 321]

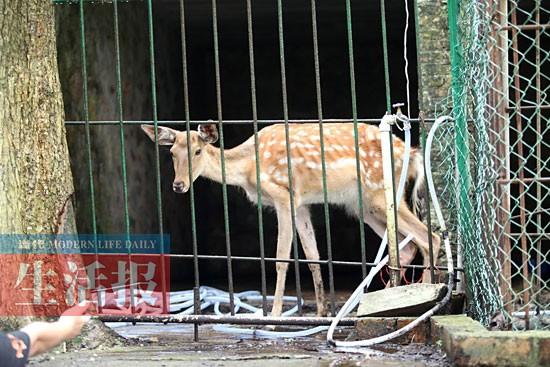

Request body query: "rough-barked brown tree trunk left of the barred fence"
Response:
[0, 0, 75, 326]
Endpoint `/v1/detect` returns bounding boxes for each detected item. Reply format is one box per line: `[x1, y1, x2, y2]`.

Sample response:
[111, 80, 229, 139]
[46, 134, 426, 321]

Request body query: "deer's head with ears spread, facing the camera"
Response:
[141, 124, 218, 194]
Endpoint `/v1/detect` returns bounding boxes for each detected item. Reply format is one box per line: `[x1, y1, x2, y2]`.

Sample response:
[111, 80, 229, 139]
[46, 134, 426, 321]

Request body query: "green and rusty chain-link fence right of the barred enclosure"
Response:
[437, 0, 550, 328]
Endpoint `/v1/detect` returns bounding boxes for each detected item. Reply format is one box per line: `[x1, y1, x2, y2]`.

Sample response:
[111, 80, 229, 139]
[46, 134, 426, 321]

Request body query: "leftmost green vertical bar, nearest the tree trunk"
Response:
[79, 0, 102, 312]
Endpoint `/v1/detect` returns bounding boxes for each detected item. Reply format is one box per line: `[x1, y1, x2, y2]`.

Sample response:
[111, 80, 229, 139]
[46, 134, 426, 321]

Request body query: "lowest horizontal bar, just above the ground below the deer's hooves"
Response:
[98, 314, 361, 326]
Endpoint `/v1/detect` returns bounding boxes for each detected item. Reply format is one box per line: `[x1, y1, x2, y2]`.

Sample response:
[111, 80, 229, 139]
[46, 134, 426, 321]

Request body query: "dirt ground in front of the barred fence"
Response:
[30, 324, 450, 367]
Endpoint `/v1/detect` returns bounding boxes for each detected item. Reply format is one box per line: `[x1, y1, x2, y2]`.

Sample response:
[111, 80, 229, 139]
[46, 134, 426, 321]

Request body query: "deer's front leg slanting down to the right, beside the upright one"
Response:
[296, 206, 326, 316]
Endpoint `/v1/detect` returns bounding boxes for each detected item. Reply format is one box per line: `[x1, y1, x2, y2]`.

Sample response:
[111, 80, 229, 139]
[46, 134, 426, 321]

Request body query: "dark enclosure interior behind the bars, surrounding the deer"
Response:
[58, 0, 418, 289]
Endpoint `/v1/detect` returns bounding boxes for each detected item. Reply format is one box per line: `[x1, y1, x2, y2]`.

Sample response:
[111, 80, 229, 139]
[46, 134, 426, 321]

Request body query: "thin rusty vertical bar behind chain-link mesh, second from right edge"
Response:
[512, 3, 540, 330]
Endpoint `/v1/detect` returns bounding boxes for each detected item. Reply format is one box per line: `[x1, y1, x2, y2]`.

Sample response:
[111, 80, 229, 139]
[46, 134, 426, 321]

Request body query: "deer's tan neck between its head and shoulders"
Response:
[202, 141, 254, 186]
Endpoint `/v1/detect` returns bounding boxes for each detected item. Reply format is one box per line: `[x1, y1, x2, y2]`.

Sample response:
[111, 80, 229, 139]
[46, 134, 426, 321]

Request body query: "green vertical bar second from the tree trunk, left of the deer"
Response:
[113, 0, 137, 313]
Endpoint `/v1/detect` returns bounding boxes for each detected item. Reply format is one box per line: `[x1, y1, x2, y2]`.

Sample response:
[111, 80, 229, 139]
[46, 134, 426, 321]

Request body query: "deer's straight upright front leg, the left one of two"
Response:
[271, 204, 293, 316]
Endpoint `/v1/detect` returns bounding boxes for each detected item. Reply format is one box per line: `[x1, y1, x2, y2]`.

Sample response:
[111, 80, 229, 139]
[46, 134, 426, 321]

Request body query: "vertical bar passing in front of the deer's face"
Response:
[180, 0, 201, 341]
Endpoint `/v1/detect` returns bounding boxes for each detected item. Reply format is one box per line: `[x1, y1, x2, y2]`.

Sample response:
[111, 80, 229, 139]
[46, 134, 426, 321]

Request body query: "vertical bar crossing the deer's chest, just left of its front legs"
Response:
[246, 0, 267, 316]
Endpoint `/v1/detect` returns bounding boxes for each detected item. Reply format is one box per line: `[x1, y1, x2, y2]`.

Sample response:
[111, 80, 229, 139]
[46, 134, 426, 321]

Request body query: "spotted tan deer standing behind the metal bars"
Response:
[141, 123, 440, 316]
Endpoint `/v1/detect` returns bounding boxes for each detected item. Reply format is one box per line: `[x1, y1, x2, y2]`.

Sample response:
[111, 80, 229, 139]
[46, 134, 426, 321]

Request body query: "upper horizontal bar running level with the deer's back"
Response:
[65, 118, 426, 125]
